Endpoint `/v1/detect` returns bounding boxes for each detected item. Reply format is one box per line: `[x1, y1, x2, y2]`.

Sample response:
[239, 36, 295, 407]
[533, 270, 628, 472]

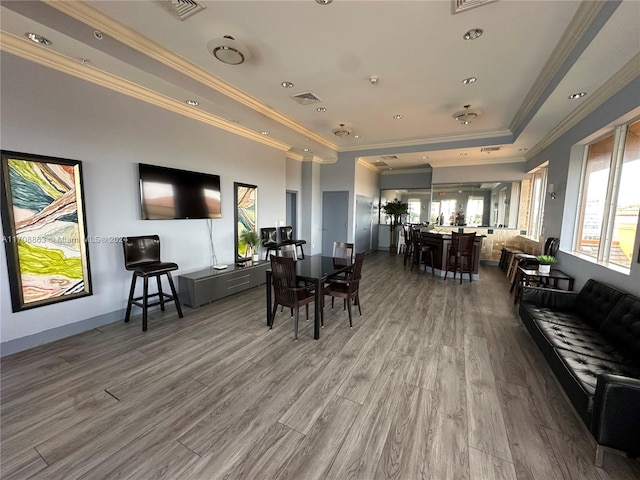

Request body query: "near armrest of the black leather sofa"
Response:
[591, 374, 640, 457]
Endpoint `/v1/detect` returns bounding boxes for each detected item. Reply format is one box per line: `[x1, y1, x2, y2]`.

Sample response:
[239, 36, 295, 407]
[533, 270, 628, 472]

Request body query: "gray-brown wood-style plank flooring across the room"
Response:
[1, 252, 640, 480]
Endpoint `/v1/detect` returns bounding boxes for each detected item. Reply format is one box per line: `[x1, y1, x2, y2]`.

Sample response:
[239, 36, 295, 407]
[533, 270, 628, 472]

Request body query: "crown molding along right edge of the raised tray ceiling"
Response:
[509, 1, 606, 132]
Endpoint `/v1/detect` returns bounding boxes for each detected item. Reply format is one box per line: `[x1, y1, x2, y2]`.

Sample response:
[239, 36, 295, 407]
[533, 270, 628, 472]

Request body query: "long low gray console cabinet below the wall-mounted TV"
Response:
[178, 261, 271, 308]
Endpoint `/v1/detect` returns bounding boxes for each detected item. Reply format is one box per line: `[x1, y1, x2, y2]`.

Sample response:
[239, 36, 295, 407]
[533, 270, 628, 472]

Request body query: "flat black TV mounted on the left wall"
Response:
[139, 163, 222, 220]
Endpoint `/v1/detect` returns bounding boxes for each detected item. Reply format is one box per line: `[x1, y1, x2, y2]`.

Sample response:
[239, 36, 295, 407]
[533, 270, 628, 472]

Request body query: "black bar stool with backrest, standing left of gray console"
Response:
[122, 235, 183, 332]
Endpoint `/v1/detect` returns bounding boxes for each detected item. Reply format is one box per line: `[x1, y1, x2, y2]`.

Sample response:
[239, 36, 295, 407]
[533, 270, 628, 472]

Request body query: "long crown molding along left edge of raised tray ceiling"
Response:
[43, 0, 338, 151]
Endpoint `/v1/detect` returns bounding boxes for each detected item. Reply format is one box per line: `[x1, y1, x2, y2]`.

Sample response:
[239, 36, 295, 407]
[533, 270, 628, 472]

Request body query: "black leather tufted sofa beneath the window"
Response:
[519, 279, 640, 466]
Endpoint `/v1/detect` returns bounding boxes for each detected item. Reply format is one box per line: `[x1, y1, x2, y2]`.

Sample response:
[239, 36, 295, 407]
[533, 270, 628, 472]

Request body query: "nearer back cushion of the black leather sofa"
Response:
[600, 295, 640, 364]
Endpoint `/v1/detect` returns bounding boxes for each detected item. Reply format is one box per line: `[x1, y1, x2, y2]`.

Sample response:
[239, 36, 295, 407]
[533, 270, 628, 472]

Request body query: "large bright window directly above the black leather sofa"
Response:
[574, 121, 640, 268]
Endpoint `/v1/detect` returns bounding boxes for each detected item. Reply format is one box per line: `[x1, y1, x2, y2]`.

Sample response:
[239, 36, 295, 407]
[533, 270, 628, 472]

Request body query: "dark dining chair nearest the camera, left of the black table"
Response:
[269, 255, 315, 340]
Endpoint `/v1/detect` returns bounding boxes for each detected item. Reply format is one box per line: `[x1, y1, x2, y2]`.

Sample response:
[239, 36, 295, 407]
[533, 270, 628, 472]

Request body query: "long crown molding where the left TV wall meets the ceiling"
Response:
[0, 31, 291, 152]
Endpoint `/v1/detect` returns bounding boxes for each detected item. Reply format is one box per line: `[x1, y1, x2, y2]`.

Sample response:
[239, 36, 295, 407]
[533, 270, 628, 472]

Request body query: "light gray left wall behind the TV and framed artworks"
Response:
[0, 54, 286, 353]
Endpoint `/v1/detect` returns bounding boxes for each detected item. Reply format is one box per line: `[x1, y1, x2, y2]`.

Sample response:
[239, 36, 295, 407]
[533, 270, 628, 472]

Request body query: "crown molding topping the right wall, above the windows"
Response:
[526, 53, 640, 159]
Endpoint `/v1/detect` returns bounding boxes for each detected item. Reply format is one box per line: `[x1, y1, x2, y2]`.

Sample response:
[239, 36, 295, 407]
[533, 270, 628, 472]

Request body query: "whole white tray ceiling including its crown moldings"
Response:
[1, 0, 640, 171]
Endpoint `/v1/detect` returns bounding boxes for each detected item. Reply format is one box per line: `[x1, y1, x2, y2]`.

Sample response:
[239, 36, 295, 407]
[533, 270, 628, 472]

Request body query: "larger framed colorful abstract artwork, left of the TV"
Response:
[0, 150, 91, 312]
